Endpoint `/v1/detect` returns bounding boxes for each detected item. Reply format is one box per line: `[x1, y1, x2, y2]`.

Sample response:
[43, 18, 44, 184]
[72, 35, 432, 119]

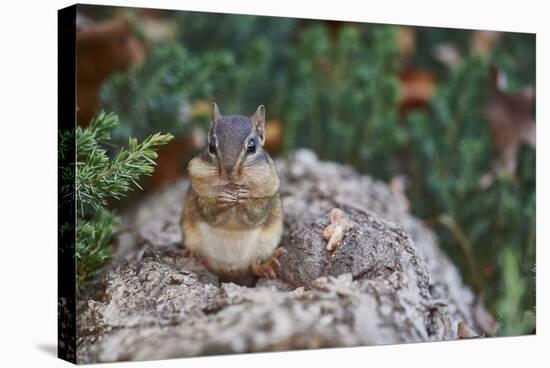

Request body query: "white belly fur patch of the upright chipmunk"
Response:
[198, 222, 266, 270]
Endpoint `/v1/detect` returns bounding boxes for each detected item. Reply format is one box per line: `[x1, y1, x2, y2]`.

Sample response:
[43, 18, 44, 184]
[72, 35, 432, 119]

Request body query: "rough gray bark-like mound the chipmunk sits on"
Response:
[77, 150, 487, 363]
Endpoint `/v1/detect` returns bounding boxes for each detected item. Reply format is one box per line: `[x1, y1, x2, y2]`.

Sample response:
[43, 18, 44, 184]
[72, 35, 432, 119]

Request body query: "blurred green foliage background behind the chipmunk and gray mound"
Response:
[87, 7, 536, 335]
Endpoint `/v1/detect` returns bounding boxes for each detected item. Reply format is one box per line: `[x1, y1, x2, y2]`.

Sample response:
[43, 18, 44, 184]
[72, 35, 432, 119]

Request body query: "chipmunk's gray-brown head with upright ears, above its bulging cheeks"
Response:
[207, 103, 267, 182]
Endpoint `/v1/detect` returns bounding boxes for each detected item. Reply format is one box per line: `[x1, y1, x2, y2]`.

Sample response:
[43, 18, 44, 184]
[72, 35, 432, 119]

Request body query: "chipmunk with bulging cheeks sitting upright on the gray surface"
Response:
[181, 103, 286, 284]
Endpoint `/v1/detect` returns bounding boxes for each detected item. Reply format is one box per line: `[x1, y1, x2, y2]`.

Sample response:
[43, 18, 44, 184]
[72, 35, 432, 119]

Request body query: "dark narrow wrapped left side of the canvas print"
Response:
[57, 5, 77, 363]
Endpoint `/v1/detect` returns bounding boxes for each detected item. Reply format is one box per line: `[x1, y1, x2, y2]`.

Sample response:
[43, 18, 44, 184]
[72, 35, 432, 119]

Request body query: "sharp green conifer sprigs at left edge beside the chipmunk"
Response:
[60, 112, 173, 287]
